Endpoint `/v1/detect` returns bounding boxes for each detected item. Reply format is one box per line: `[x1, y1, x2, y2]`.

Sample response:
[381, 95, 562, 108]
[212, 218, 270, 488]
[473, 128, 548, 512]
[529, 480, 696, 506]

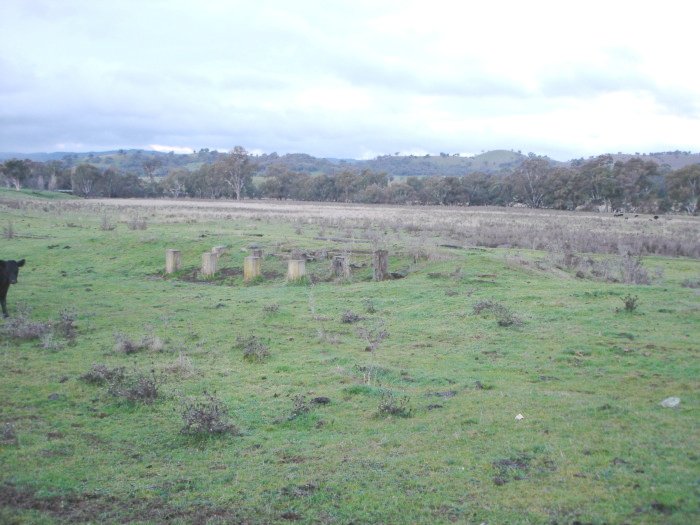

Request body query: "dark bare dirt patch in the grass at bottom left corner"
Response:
[0, 483, 252, 524]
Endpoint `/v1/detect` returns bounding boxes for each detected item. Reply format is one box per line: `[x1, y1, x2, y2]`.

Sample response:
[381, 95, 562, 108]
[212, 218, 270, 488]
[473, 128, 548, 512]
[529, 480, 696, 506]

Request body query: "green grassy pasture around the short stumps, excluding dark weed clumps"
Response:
[0, 192, 700, 524]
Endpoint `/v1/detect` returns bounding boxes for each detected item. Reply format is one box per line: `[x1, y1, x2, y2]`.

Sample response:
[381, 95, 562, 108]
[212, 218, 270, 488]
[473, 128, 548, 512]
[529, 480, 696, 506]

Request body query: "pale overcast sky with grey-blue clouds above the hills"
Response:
[0, 0, 700, 160]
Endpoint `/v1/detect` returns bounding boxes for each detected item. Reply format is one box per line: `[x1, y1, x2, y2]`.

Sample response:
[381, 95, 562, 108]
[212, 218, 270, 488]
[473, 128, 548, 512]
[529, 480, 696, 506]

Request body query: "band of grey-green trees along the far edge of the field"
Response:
[0, 146, 700, 214]
